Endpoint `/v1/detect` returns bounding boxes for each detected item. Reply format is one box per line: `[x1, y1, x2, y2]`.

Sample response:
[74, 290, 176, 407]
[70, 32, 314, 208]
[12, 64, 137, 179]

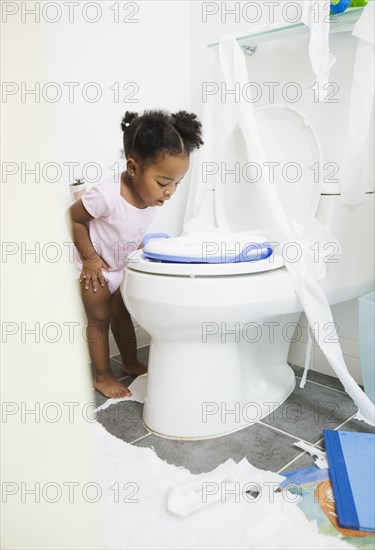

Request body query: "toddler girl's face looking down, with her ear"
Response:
[127, 154, 189, 208]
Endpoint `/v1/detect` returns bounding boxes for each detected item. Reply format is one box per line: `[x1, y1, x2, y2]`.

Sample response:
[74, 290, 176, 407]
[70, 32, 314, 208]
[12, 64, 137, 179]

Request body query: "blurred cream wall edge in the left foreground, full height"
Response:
[1, 3, 106, 549]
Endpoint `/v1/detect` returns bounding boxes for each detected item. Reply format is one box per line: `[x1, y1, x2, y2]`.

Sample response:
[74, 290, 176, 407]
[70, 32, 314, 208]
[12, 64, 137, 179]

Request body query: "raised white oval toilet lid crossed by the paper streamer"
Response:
[219, 104, 323, 236]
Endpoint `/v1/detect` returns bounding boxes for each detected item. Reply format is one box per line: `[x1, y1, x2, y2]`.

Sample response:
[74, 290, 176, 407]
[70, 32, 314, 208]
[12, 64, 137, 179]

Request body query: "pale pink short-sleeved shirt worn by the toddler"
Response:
[76, 176, 156, 271]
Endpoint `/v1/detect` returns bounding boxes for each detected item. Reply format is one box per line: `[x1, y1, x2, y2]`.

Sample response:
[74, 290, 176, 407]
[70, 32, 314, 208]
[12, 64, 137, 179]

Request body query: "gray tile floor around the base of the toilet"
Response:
[95, 347, 375, 474]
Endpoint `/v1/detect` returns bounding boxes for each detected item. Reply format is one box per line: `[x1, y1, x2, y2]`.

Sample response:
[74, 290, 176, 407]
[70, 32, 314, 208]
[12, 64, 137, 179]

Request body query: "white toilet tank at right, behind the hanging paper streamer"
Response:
[316, 192, 375, 304]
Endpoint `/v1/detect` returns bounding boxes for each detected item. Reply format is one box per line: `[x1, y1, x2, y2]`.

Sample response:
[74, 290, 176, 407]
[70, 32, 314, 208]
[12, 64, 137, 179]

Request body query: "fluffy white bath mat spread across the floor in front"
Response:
[91, 423, 353, 550]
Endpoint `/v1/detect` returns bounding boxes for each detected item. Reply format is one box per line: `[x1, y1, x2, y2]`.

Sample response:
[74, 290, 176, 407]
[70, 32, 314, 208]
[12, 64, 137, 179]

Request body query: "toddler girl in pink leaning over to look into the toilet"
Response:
[69, 110, 203, 398]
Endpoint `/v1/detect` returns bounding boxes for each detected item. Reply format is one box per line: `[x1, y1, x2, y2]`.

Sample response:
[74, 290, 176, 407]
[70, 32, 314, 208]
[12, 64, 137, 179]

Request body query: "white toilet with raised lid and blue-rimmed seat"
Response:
[121, 105, 374, 439]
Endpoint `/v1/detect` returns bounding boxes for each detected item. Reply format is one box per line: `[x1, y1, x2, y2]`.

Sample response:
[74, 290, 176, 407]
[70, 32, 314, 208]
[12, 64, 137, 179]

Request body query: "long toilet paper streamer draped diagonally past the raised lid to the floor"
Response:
[209, 35, 375, 425]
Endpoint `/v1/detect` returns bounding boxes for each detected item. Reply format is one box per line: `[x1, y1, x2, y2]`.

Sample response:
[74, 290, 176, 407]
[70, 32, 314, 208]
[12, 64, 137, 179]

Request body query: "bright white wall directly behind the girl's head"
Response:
[53, 1, 190, 234]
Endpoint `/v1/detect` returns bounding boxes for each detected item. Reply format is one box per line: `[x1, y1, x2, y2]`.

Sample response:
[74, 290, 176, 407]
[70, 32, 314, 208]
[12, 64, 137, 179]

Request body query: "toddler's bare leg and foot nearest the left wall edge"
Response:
[80, 281, 131, 397]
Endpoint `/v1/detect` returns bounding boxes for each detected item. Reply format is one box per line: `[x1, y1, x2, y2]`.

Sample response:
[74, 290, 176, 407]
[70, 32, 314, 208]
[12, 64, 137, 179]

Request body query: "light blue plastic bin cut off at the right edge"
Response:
[359, 291, 375, 404]
